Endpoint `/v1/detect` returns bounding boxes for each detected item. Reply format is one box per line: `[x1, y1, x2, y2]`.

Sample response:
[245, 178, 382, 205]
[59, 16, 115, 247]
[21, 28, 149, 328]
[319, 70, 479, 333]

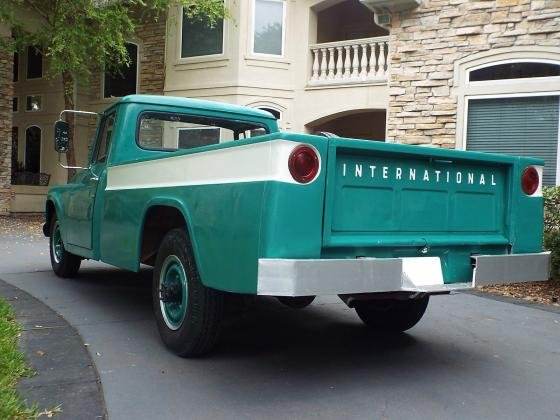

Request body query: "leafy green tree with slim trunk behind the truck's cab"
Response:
[0, 0, 227, 178]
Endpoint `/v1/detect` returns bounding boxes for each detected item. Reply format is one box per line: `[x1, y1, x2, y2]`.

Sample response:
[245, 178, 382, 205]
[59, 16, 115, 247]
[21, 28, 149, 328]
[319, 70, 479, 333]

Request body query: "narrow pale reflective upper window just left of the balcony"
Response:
[253, 0, 285, 56]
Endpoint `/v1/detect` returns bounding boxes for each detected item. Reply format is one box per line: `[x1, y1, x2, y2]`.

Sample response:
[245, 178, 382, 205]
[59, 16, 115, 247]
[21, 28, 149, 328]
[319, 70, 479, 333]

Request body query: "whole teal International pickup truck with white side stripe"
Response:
[44, 95, 549, 356]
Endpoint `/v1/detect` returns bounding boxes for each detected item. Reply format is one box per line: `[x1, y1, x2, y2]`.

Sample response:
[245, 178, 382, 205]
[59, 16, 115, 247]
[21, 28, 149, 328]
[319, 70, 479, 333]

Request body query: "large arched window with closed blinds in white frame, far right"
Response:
[464, 59, 560, 185]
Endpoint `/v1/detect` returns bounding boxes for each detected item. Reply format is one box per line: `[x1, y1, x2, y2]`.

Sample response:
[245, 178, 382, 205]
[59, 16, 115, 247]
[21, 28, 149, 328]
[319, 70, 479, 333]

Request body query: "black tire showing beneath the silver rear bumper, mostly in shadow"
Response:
[355, 295, 430, 332]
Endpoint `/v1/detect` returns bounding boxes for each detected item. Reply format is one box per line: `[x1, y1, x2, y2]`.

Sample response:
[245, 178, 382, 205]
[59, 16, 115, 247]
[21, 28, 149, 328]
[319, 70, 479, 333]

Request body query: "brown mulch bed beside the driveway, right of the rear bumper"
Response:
[478, 281, 560, 306]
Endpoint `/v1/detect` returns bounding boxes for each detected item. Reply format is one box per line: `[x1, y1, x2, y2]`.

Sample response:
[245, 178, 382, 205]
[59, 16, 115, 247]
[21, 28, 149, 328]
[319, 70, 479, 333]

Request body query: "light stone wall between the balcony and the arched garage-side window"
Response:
[387, 0, 560, 148]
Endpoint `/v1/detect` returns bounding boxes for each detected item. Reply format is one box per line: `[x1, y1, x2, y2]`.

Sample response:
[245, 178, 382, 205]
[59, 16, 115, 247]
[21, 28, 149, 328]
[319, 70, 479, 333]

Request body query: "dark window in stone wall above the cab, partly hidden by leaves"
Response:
[103, 42, 138, 98]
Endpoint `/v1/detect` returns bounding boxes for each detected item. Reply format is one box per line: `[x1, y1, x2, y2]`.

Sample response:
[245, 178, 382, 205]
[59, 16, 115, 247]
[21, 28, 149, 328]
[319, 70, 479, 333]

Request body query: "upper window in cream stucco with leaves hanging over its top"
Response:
[181, 10, 224, 58]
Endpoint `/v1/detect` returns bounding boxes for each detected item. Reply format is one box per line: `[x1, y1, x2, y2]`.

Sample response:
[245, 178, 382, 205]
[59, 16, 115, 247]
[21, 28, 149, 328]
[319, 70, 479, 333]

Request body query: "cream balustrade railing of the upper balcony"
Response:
[308, 36, 389, 86]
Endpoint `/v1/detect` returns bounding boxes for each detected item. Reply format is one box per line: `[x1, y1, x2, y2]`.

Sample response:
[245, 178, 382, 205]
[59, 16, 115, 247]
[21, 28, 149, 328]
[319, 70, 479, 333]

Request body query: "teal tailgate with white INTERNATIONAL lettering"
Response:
[323, 139, 512, 247]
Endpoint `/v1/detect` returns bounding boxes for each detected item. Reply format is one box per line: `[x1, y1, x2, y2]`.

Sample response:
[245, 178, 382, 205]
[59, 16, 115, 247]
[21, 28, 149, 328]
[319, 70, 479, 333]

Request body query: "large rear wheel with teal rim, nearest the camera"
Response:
[152, 229, 224, 357]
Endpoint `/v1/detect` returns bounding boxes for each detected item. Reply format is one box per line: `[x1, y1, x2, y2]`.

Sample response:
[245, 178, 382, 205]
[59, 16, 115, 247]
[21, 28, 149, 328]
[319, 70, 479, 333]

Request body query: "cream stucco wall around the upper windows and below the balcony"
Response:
[165, 0, 388, 132]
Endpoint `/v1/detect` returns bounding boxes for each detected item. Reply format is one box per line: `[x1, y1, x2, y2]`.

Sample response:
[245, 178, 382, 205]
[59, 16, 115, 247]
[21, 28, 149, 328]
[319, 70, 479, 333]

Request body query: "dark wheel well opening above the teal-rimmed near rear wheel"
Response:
[140, 206, 187, 266]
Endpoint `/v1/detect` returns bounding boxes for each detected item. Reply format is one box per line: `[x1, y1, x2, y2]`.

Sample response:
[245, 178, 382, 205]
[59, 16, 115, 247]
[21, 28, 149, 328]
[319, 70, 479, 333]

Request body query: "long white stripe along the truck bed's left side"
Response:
[106, 140, 320, 190]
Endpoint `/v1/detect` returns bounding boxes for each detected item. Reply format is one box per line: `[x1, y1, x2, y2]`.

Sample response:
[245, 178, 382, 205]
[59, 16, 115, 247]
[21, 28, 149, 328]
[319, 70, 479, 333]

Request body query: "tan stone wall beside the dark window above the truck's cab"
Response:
[90, 15, 166, 101]
